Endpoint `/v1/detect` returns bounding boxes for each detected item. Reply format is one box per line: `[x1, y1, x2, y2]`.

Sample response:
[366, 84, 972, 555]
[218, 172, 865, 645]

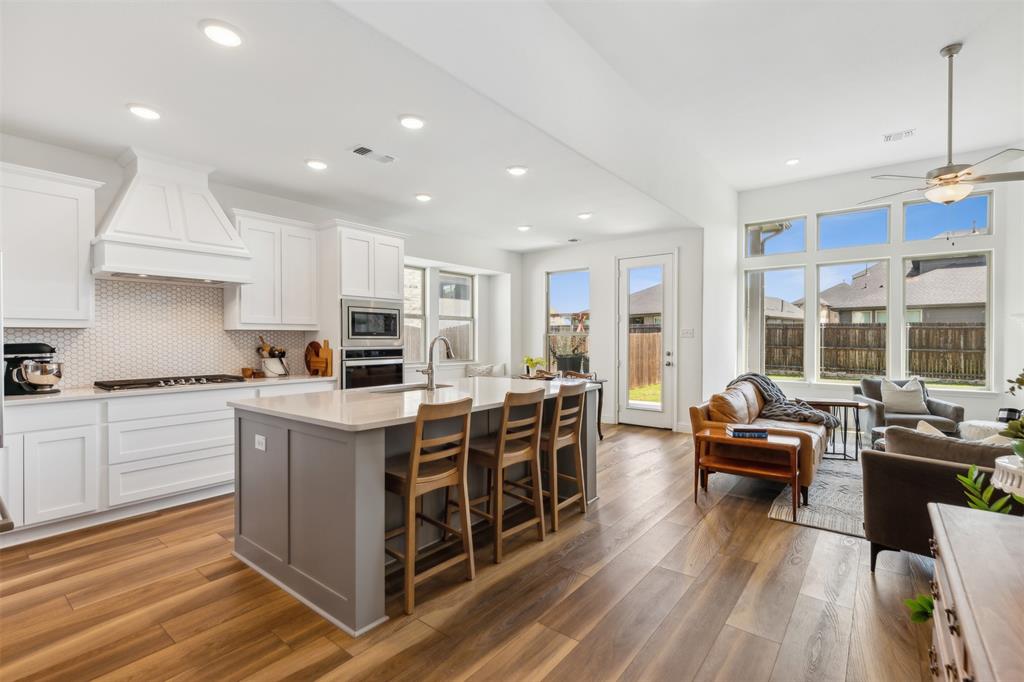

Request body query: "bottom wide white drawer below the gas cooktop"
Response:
[108, 446, 234, 507]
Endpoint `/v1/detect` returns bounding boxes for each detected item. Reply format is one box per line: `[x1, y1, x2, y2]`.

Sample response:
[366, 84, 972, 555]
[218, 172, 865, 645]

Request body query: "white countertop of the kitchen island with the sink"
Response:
[227, 377, 599, 431]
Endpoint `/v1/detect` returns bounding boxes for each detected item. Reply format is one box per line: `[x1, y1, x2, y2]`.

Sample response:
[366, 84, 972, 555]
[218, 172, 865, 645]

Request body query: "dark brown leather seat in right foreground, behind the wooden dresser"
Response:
[860, 426, 1024, 570]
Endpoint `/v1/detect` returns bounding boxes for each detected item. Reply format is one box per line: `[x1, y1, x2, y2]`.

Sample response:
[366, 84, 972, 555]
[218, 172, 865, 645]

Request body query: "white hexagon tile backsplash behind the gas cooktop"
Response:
[4, 280, 306, 388]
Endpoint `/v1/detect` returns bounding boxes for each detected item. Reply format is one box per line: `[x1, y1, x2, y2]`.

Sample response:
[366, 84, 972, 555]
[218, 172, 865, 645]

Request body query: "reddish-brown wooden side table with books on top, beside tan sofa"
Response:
[693, 429, 800, 521]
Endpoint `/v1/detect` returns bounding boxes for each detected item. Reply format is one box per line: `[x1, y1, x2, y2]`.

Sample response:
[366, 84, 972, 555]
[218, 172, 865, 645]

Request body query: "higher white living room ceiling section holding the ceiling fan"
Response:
[550, 1, 1024, 189]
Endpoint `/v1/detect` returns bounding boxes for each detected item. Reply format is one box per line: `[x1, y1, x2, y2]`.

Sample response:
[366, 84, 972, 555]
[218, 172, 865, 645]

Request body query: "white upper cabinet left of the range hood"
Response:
[0, 163, 103, 328]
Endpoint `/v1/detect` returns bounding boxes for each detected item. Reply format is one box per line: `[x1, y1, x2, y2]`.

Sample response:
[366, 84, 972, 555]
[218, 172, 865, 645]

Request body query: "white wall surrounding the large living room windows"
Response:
[736, 142, 1024, 419]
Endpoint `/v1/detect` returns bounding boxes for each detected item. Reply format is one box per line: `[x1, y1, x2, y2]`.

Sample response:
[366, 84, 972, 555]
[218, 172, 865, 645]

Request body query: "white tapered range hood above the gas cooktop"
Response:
[92, 148, 252, 286]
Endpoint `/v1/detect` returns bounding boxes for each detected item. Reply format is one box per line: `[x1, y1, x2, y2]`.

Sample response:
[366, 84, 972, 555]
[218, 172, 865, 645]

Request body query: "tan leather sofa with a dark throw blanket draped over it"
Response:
[690, 381, 828, 504]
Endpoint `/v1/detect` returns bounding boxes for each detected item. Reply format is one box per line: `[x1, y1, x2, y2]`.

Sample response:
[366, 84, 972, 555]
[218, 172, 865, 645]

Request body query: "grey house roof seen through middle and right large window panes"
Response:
[820, 256, 988, 310]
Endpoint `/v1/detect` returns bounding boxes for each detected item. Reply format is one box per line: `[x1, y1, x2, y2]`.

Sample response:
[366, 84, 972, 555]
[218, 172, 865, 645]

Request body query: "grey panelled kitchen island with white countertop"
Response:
[228, 377, 598, 635]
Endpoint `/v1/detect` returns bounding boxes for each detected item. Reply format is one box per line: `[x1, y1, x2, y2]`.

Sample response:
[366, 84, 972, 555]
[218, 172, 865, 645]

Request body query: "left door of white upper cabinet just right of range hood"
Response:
[239, 218, 281, 325]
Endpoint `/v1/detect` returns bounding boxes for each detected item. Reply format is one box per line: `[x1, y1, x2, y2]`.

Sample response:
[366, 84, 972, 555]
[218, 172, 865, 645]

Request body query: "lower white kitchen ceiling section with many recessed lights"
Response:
[0, 2, 686, 250]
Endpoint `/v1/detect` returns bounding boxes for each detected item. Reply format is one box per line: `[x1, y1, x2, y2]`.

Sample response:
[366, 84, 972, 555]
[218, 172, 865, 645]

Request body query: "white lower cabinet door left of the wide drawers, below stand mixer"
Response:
[23, 426, 99, 523]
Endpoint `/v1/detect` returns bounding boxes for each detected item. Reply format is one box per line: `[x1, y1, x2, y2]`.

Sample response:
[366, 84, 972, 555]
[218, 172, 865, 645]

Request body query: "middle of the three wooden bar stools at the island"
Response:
[460, 388, 545, 563]
